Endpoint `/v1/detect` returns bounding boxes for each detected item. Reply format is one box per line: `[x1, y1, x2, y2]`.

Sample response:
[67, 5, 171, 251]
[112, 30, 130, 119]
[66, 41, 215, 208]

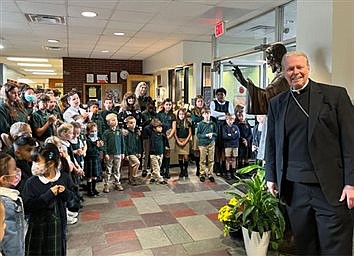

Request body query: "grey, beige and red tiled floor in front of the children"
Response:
[68, 164, 252, 256]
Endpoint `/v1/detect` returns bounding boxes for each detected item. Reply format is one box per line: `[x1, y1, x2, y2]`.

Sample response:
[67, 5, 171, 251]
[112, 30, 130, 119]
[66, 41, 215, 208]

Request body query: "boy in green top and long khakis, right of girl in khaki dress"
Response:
[197, 108, 217, 182]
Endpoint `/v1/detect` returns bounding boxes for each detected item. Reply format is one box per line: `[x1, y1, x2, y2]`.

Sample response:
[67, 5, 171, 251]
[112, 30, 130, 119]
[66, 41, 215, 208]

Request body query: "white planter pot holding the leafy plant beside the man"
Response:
[242, 227, 270, 256]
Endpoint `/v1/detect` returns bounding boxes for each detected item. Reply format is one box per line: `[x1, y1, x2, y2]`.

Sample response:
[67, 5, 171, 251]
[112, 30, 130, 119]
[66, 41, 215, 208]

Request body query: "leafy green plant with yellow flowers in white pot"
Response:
[218, 164, 285, 255]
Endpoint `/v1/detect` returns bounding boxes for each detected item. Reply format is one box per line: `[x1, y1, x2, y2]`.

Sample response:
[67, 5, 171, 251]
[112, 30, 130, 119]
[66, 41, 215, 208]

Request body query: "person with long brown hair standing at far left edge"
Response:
[0, 83, 28, 134]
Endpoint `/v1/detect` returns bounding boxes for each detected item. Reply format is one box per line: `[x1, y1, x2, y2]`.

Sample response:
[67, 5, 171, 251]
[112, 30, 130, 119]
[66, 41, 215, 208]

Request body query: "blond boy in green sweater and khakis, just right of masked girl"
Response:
[102, 113, 125, 193]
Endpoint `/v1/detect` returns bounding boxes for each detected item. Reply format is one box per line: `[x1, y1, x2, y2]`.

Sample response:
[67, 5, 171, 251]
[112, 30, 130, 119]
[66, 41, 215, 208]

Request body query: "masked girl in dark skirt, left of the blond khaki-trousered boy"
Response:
[84, 122, 103, 197]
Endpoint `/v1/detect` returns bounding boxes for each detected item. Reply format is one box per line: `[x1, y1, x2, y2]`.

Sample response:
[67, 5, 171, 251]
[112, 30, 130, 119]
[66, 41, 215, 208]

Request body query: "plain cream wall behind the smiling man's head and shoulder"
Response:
[296, 0, 354, 99]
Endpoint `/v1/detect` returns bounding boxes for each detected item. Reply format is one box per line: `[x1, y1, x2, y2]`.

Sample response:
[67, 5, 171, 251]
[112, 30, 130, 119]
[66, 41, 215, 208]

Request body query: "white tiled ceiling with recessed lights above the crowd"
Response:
[0, 0, 286, 82]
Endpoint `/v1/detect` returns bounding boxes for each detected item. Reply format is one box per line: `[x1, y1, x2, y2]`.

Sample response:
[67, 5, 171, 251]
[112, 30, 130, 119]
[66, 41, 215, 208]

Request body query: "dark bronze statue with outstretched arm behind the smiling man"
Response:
[233, 44, 289, 115]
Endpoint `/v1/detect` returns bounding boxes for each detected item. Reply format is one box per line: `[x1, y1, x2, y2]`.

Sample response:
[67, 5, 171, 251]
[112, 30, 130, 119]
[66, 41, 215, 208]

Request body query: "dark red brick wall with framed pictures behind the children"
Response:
[63, 57, 143, 97]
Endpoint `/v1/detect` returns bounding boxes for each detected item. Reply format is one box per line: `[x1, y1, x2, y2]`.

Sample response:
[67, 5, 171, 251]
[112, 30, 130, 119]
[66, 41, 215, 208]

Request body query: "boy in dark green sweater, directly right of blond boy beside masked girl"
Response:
[124, 116, 142, 186]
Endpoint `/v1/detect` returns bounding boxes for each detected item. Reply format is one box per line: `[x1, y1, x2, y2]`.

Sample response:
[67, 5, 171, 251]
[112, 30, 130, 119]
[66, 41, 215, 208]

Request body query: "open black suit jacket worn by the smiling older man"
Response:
[266, 80, 354, 205]
